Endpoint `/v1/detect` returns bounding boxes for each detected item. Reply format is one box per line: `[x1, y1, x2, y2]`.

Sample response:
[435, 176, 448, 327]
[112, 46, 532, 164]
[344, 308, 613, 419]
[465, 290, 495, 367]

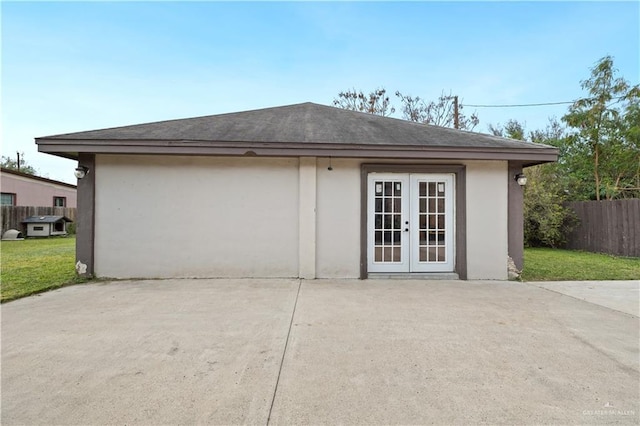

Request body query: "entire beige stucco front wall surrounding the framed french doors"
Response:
[95, 155, 508, 279]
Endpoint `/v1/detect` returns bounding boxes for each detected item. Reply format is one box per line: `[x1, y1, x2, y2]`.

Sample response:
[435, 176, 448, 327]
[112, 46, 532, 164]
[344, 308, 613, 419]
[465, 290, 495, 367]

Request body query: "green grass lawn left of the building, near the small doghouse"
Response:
[0, 237, 86, 302]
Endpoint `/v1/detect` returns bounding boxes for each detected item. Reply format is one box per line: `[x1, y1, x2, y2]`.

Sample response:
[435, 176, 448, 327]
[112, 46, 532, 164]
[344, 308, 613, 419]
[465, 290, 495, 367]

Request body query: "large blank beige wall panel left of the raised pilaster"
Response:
[95, 155, 299, 278]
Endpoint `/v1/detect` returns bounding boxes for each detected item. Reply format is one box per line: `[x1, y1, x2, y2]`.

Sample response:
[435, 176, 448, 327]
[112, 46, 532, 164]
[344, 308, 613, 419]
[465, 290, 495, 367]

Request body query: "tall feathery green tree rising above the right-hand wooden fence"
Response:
[560, 56, 640, 200]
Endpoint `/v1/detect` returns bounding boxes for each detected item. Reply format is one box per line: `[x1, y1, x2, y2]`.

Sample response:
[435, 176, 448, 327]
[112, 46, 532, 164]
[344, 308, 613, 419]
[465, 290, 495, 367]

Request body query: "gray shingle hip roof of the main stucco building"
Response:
[38, 102, 549, 149]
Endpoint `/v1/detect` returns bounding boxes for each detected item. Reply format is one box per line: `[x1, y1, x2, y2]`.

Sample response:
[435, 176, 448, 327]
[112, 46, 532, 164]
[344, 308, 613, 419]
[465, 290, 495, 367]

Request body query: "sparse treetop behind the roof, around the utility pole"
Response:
[396, 91, 480, 131]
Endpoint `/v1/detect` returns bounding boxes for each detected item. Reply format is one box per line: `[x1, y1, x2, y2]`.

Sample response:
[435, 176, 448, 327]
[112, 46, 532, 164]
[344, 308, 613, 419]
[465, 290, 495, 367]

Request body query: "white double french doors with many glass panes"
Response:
[367, 173, 455, 273]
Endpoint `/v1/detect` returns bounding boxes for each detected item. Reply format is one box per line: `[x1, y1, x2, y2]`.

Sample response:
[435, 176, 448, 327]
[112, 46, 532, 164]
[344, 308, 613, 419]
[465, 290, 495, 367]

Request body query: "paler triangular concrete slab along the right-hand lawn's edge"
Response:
[527, 280, 640, 317]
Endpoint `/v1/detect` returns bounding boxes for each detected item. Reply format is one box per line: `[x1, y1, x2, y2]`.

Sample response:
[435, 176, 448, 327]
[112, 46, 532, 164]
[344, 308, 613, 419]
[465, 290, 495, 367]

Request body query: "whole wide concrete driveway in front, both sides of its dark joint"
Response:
[1, 280, 640, 425]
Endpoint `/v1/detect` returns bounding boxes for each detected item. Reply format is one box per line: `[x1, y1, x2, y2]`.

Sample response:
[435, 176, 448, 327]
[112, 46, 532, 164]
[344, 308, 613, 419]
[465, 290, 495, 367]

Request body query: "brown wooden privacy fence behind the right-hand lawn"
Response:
[567, 198, 640, 257]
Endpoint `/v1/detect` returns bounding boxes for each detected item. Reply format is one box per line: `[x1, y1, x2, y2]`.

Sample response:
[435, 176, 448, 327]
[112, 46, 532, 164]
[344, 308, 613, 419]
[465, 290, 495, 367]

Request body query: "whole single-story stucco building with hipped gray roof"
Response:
[36, 103, 558, 280]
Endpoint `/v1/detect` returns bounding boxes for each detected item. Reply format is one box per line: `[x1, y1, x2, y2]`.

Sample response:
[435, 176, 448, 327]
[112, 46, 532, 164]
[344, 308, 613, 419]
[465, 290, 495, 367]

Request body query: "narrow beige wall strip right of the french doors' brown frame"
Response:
[467, 161, 509, 280]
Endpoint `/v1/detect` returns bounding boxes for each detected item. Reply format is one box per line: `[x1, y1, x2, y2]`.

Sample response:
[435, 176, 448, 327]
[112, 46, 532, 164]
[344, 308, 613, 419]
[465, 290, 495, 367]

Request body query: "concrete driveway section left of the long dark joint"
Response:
[1, 280, 298, 425]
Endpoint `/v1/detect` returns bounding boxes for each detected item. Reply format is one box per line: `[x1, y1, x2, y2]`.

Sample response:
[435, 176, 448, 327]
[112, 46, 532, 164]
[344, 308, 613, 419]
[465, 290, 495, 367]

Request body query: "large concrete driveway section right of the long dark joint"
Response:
[271, 280, 640, 424]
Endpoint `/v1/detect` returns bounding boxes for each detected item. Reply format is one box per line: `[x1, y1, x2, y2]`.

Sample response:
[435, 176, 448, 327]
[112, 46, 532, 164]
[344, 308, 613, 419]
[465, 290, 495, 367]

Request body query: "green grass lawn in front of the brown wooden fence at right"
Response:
[522, 248, 640, 281]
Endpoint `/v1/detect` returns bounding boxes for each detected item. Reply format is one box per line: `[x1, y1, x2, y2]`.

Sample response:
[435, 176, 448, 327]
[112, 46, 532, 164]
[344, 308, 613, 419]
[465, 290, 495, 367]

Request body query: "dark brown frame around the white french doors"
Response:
[360, 163, 467, 280]
